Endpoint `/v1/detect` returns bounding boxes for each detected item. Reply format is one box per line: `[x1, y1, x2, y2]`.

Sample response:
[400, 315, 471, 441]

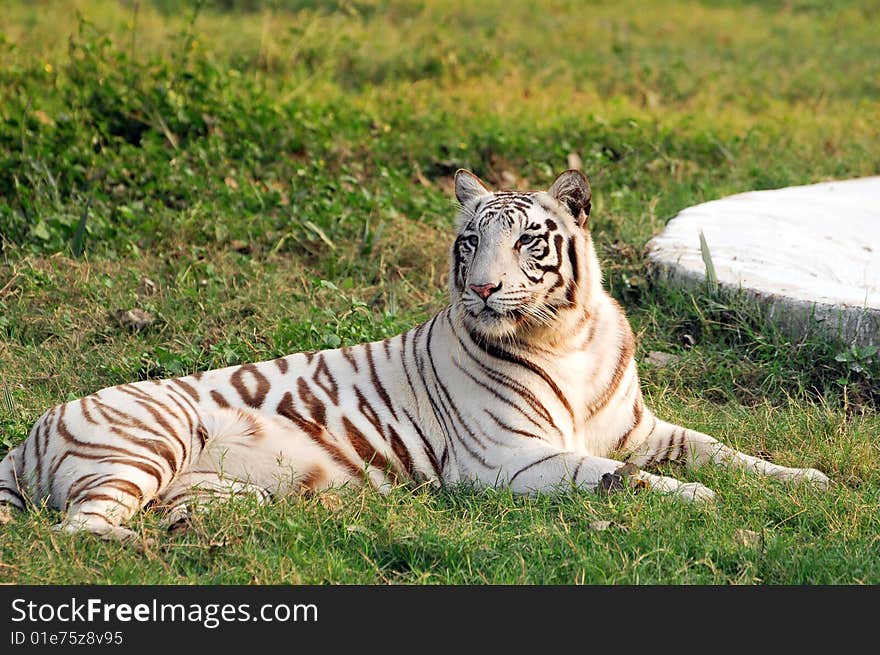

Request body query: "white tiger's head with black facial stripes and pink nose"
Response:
[449, 169, 601, 341]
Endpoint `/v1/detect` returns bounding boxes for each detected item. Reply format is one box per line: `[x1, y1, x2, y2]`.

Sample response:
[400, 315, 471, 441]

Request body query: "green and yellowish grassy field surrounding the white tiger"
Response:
[0, 0, 880, 584]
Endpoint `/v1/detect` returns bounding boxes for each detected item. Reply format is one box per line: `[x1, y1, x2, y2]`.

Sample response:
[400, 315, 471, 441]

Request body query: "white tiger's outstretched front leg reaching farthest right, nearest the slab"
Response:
[627, 416, 830, 487]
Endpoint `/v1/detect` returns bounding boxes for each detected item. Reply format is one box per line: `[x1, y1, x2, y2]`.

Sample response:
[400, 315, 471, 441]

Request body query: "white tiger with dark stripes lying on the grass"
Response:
[0, 171, 827, 539]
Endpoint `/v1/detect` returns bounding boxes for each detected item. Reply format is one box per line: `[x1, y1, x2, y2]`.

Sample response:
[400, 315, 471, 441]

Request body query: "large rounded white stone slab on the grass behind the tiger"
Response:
[648, 177, 880, 344]
